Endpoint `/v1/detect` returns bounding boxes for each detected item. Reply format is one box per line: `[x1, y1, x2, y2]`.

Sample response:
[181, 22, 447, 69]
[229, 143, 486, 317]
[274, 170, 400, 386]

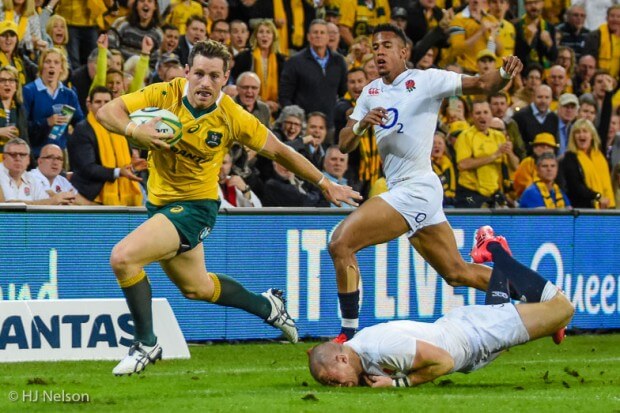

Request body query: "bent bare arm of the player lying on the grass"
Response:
[364, 340, 454, 387]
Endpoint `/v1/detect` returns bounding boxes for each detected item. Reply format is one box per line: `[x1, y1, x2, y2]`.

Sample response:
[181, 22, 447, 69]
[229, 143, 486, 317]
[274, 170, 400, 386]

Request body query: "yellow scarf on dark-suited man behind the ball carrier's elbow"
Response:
[86, 112, 142, 206]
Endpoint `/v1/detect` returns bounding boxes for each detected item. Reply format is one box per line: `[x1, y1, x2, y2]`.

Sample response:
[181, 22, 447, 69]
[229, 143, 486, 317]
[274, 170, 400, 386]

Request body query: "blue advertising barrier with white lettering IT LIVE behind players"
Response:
[0, 207, 620, 340]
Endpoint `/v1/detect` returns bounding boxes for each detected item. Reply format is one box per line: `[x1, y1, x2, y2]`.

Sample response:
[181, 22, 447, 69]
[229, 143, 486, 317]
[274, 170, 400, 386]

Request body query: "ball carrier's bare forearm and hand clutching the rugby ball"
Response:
[97, 98, 173, 149]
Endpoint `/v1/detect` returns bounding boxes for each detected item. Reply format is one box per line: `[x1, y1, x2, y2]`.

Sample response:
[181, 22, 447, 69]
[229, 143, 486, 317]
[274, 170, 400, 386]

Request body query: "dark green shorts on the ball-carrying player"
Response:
[146, 199, 220, 254]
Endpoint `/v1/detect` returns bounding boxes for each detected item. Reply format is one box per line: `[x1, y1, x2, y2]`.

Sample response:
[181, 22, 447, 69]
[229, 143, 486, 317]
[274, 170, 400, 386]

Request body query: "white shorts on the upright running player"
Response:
[379, 173, 447, 238]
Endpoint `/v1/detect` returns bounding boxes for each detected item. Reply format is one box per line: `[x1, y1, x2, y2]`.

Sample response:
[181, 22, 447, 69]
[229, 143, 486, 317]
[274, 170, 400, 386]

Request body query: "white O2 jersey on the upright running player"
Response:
[350, 69, 462, 187]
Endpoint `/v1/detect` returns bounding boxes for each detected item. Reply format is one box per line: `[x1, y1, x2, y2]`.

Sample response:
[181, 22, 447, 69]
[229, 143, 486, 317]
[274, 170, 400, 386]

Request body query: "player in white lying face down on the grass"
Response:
[308, 227, 574, 387]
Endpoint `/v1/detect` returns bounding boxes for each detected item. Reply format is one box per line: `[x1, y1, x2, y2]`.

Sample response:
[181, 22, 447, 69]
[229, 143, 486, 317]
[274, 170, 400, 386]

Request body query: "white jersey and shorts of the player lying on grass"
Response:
[344, 304, 529, 377]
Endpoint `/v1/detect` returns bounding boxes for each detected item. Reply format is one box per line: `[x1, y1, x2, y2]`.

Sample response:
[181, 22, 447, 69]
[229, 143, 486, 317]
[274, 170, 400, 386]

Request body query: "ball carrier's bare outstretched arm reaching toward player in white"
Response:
[260, 131, 362, 206]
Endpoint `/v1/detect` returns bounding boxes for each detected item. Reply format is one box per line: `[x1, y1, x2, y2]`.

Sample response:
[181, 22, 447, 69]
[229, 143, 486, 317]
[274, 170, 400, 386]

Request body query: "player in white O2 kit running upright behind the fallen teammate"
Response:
[329, 24, 523, 343]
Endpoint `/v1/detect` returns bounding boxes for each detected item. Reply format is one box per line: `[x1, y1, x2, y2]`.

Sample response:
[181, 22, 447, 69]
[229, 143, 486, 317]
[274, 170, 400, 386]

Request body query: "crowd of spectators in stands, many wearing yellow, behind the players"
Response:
[0, 0, 620, 209]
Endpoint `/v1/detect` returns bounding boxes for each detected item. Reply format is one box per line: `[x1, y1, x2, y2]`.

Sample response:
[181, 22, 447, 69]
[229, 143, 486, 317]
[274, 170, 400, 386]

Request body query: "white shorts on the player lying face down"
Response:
[442, 303, 530, 372]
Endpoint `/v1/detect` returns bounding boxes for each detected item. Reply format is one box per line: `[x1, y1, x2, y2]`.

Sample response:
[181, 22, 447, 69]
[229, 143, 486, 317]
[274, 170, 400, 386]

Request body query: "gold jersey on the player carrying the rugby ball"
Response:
[121, 78, 268, 206]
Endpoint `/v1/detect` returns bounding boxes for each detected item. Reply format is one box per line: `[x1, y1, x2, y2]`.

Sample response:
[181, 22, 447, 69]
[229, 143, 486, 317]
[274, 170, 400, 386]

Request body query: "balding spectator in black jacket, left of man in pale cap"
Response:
[513, 85, 559, 155]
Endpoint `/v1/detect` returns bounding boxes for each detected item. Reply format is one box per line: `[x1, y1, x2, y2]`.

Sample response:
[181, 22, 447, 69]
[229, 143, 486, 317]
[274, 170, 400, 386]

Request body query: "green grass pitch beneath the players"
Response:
[0, 334, 620, 413]
